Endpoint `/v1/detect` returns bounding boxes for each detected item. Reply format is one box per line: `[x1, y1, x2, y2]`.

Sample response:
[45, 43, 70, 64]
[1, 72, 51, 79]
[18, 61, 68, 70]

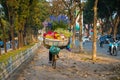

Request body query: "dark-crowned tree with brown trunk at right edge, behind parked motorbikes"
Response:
[98, 0, 120, 39]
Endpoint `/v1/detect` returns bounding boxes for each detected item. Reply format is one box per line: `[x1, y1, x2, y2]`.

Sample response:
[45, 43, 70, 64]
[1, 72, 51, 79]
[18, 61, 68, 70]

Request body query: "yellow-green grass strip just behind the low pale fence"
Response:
[0, 44, 34, 62]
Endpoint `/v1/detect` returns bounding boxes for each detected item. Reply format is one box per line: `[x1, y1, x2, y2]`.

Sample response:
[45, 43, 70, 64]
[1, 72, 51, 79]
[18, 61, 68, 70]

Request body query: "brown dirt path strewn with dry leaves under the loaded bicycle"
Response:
[8, 46, 120, 80]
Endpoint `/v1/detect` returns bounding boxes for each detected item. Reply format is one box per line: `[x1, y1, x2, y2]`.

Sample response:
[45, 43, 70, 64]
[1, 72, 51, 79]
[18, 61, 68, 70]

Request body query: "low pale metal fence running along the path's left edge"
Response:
[0, 43, 41, 80]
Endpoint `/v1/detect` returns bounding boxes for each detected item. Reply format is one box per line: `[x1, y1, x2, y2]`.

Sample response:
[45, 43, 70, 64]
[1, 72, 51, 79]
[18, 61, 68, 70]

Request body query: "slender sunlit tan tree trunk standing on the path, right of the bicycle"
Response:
[92, 0, 98, 60]
